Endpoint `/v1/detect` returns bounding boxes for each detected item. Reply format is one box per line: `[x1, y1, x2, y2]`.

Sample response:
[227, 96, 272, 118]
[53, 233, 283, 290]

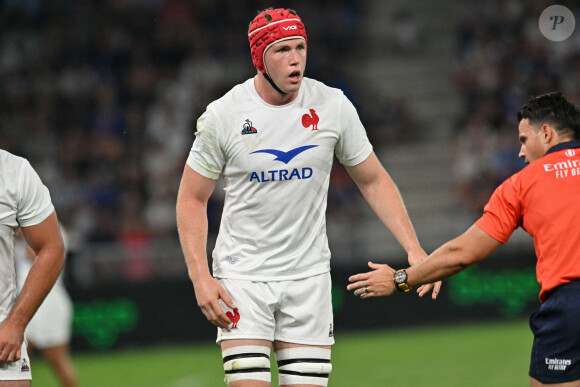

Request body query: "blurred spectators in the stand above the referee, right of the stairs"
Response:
[454, 0, 580, 216]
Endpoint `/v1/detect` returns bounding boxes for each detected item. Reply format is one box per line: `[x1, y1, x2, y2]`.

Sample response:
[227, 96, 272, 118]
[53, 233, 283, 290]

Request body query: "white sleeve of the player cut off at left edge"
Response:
[16, 160, 54, 227]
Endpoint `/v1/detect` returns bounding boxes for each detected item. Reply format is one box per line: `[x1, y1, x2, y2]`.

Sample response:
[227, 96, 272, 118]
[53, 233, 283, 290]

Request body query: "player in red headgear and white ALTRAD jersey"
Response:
[177, 9, 439, 387]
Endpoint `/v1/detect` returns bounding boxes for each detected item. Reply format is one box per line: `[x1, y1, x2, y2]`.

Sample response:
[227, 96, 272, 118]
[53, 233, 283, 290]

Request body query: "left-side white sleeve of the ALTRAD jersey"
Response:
[187, 109, 225, 180]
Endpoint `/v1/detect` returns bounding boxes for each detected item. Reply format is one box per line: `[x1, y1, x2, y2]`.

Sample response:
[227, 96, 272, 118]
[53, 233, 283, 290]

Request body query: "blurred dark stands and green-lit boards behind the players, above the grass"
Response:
[0, 0, 580, 364]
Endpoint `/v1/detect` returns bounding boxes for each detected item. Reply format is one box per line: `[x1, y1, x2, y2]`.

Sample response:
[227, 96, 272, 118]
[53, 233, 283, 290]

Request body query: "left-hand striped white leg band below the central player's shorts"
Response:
[222, 345, 271, 384]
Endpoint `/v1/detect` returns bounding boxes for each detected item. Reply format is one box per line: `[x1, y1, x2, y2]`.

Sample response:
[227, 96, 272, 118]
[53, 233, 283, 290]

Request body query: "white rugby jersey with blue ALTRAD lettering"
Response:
[187, 78, 372, 281]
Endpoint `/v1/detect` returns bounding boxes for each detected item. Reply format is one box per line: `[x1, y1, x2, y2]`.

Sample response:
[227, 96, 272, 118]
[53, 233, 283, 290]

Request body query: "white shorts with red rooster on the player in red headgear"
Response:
[217, 273, 334, 345]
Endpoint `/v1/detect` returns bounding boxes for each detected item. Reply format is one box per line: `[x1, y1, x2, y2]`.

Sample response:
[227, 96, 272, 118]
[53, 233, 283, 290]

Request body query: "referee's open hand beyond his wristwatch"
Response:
[346, 262, 397, 298]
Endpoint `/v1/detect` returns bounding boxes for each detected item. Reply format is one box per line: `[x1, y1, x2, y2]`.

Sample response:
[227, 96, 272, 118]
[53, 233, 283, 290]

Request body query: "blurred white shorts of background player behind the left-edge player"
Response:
[25, 283, 73, 349]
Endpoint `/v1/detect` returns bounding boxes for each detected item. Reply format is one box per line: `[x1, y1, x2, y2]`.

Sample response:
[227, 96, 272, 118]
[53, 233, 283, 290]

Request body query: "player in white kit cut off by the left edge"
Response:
[0, 150, 65, 387]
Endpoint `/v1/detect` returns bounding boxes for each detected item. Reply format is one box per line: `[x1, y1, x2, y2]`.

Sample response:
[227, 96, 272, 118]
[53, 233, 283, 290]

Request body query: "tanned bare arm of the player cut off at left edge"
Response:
[0, 211, 65, 362]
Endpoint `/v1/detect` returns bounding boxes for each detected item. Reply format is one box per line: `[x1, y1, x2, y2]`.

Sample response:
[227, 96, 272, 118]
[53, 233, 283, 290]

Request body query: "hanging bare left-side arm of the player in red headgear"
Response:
[177, 165, 235, 328]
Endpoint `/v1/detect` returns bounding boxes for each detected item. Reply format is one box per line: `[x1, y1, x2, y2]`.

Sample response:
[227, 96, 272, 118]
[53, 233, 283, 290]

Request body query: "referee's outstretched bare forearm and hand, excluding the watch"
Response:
[347, 225, 502, 298]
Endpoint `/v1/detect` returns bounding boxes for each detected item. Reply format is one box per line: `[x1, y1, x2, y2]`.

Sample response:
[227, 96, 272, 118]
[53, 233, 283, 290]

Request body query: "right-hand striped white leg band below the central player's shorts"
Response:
[276, 347, 332, 386]
